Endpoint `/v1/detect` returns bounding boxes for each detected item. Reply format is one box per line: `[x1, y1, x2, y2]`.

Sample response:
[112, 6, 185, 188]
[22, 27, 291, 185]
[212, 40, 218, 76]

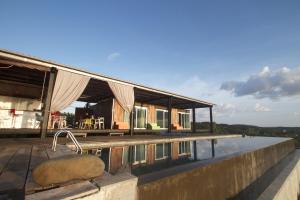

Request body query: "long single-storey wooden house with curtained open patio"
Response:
[0, 50, 213, 138]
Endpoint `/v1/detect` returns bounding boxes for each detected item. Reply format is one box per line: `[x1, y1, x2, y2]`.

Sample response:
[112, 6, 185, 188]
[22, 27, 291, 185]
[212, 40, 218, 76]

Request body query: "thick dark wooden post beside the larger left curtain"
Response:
[41, 67, 57, 139]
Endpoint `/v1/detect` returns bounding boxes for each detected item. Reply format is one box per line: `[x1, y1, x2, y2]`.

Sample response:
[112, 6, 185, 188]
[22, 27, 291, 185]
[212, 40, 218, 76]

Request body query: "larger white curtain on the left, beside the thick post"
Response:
[50, 70, 90, 112]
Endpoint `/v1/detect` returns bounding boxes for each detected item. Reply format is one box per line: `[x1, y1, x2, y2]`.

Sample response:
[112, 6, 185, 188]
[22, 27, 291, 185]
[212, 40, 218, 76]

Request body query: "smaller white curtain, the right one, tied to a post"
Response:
[108, 81, 134, 113]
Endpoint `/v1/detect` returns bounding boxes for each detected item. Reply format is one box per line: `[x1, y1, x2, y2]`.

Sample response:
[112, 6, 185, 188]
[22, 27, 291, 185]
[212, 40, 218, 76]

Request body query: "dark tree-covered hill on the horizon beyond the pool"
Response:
[196, 122, 300, 147]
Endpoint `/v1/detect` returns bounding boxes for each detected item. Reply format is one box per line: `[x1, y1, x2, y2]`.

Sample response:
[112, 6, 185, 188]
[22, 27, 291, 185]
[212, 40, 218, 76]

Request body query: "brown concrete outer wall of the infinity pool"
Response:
[138, 140, 295, 200]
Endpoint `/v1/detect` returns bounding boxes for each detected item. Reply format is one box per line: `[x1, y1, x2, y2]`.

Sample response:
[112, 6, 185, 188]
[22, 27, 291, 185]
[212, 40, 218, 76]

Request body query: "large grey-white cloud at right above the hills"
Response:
[221, 67, 300, 99]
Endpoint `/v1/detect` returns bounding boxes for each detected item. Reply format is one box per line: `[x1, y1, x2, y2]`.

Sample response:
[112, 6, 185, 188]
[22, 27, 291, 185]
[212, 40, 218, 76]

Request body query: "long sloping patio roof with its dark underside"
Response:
[0, 49, 214, 109]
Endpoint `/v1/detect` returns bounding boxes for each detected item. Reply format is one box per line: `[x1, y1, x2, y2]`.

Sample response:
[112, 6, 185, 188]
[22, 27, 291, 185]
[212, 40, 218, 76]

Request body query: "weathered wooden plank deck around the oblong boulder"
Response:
[0, 143, 98, 199]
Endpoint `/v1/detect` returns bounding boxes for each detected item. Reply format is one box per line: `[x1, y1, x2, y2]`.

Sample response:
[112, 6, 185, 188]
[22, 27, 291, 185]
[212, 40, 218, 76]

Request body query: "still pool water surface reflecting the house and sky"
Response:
[94, 137, 288, 176]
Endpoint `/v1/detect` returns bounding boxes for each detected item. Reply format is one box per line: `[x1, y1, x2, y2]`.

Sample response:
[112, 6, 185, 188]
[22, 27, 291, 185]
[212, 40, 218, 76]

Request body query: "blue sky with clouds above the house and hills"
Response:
[0, 0, 300, 127]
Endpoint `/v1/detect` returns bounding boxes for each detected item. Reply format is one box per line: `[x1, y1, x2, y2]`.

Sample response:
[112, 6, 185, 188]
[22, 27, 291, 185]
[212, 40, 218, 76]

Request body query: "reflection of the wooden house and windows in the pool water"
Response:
[101, 141, 191, 173]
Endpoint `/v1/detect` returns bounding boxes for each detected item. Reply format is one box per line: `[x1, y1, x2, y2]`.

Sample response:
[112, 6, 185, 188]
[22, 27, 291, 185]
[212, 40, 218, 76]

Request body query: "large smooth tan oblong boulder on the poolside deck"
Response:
[32, 155, 105, 186]
